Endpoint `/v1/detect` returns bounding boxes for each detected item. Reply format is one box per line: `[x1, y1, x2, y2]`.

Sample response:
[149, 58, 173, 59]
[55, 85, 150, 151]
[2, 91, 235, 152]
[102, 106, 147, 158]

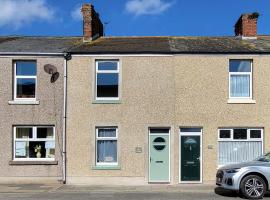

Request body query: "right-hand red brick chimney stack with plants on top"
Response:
[234, 12, 259, 38]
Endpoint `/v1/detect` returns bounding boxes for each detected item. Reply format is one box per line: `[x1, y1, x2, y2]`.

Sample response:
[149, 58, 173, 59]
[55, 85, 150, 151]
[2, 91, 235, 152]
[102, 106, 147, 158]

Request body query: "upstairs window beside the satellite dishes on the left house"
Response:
[14, 61, 37, 100]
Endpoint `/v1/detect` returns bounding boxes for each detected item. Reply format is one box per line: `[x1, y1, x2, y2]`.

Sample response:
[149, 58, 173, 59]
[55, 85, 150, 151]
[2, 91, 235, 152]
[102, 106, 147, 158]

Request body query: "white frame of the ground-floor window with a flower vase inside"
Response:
[13, 126, 56, 161]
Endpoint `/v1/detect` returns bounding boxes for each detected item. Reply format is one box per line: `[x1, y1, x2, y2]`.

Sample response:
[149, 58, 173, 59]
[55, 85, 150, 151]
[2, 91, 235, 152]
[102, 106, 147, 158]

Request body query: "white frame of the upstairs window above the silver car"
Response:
[229, 59, 253, 100]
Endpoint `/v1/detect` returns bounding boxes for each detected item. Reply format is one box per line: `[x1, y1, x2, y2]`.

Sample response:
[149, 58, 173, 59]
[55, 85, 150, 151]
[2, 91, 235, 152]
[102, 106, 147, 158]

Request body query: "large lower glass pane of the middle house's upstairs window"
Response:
[97, 73, 118, 97]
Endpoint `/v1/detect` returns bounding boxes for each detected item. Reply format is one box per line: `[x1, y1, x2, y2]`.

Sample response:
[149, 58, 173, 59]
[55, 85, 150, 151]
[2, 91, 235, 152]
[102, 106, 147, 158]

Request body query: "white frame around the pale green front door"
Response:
[148, 127, 171, 183]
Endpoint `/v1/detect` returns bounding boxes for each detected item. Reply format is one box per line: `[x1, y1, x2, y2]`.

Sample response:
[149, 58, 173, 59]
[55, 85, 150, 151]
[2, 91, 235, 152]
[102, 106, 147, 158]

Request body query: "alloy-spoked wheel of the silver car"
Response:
[240, 175, 266, 199]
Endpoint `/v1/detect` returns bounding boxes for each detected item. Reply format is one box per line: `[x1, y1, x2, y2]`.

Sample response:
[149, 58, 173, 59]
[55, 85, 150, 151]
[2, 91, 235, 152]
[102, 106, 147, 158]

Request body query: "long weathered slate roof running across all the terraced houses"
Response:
[0, 36, 270, 54]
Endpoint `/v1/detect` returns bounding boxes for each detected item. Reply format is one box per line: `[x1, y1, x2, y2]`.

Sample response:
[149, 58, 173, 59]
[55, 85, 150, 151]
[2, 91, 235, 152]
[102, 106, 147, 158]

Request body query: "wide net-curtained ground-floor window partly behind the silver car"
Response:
[218, 128, 263, 165]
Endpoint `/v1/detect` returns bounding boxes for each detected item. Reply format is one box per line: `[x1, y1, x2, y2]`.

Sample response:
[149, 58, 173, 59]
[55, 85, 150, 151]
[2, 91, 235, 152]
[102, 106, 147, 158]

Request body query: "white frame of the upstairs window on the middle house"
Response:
[95, 59, 120, 101]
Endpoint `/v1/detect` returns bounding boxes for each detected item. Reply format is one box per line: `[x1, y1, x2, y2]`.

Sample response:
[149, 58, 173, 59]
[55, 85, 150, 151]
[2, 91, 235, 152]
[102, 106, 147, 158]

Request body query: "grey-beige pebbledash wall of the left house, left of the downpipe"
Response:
[0, 56, 64, 183]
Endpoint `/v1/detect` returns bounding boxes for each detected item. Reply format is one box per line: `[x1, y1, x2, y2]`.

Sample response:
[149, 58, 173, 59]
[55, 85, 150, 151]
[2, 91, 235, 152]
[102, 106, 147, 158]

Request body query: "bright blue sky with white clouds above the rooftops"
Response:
[0, 0, 270, 36]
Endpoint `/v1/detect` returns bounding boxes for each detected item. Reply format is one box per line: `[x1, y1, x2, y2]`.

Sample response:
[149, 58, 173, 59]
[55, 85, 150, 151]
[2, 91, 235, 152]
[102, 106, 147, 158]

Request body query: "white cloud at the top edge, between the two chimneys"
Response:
[126, 0, 173, 16]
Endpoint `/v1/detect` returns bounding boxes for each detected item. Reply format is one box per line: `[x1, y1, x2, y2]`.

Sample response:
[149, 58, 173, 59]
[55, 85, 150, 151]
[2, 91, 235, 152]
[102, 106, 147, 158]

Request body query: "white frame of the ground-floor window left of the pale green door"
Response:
[95, 126, 119, 166]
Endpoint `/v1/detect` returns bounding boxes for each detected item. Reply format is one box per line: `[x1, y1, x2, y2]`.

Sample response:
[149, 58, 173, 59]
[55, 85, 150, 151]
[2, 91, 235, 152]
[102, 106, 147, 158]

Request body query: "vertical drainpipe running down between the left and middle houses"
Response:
[62, 53, 71, 184]
